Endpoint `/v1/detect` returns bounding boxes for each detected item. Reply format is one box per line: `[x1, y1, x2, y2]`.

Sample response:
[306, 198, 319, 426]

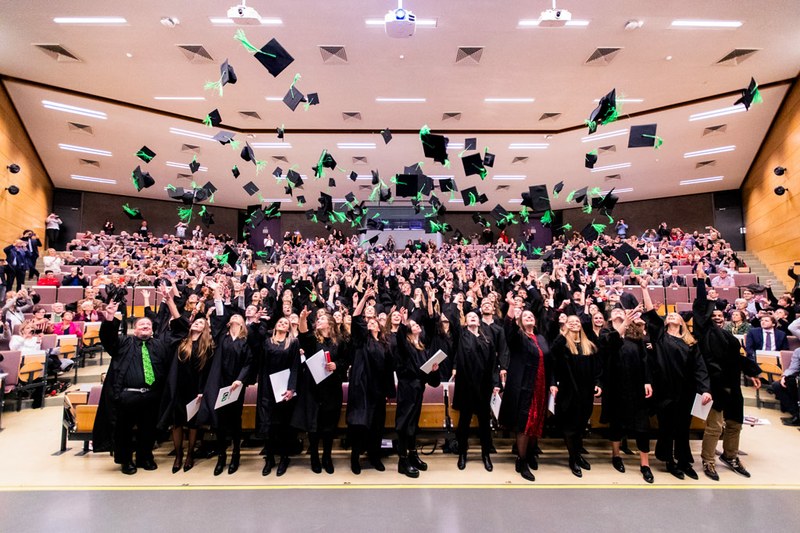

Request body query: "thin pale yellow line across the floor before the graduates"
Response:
[0, 483, 800, 492]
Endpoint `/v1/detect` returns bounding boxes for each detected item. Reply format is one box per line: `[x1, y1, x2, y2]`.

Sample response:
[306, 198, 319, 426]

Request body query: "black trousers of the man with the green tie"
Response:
[114, 391, 159, 464]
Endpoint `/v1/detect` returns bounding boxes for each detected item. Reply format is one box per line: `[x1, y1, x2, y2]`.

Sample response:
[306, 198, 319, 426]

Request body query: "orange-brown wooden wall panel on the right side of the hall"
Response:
[742, 76, 800, 286]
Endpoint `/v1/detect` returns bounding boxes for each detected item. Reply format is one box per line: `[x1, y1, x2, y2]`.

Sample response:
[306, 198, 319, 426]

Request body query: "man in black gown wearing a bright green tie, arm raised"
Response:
[92, 302, 174, 475]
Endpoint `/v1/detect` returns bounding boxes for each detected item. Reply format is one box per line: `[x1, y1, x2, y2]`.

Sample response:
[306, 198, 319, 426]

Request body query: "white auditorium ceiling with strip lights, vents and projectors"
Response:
[0, 0, 800, 210]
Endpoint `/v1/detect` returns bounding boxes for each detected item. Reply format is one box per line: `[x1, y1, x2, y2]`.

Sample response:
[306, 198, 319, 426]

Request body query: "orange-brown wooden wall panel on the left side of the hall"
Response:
[0, 84, 53, 248]
